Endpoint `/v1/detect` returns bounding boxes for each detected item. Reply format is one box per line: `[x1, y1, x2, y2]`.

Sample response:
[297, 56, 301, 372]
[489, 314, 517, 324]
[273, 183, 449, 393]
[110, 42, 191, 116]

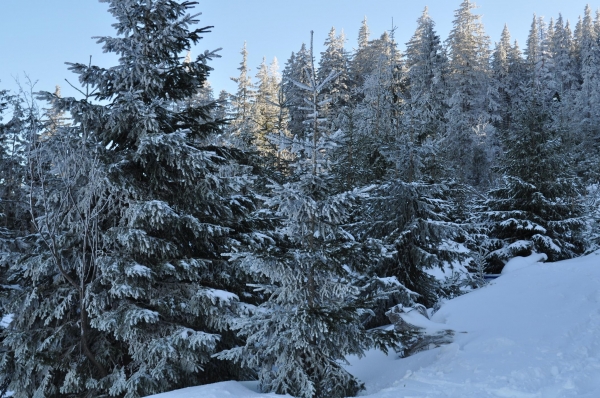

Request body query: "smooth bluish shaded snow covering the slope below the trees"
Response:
[146, 251, 600, 398]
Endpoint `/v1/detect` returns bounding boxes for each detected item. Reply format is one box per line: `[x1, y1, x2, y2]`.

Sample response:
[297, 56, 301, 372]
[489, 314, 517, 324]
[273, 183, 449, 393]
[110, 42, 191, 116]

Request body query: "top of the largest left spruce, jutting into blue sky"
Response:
[73, 0, 218, 103]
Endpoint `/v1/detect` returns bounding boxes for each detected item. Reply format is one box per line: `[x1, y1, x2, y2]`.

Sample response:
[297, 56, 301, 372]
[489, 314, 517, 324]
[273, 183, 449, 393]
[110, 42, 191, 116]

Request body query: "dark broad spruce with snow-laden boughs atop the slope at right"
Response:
[484, 100, 584, 272]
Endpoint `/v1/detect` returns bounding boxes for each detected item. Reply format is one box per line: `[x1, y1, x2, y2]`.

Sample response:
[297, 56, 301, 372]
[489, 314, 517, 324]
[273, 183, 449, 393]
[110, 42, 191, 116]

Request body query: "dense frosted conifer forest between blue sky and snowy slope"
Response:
[0, 0, 600, 398]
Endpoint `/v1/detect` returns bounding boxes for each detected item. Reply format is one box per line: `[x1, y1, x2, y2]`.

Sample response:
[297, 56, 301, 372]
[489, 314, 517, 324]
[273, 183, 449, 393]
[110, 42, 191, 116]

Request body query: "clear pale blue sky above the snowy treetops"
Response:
[0, 0, 597, 96]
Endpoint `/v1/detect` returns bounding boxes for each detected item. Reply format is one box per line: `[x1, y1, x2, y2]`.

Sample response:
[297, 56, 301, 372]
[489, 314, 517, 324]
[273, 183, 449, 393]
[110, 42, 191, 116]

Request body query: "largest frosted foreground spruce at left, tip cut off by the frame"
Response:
[0, 0, 252, 397]
